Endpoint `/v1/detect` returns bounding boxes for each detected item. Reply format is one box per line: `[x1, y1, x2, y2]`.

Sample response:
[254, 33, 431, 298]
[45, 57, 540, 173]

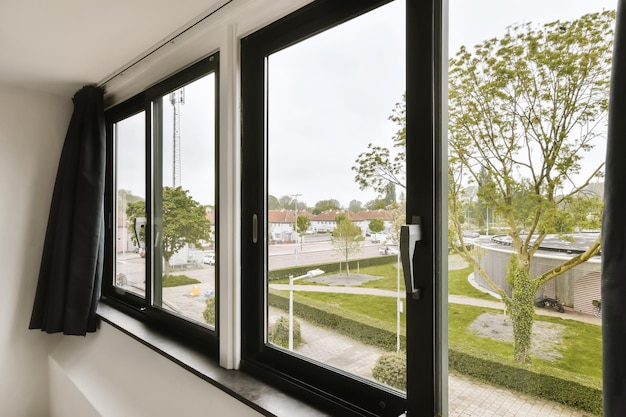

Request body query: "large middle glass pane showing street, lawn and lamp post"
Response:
[266, 1, 405, 390]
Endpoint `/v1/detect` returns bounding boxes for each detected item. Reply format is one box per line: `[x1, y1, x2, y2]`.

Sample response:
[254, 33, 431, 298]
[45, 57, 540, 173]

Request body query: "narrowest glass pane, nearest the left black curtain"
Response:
[113, 112, 146, 297]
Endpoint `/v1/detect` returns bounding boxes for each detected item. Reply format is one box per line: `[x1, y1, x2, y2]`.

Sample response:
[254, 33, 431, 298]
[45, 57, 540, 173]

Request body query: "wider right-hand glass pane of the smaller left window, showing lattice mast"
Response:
[152, 74, 217, 327]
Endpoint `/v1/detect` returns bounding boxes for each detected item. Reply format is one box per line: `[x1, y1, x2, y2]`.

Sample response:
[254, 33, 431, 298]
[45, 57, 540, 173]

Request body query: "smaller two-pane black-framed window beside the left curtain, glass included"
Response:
[103, 54, 219, 346]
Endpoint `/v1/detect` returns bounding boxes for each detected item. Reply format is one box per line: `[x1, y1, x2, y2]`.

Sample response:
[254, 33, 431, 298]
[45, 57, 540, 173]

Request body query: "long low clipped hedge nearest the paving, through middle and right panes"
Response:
[269, 290, 602, 416]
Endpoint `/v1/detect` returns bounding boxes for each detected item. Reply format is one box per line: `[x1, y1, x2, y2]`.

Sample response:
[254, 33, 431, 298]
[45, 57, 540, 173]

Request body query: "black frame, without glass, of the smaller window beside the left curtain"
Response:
[102, 51, 220, 357]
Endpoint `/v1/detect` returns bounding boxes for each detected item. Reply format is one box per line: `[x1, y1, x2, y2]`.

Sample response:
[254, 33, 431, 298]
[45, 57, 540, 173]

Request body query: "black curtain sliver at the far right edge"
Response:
[602, 0, 626, 417]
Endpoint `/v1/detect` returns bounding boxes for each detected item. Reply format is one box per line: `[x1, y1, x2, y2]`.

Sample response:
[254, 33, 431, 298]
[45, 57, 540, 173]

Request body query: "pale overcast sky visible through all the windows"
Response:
[118, 0, 617, 207]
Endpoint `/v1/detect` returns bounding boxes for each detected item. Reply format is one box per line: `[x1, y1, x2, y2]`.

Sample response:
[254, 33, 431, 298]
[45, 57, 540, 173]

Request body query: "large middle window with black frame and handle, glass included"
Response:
[242, 0, 438, 416]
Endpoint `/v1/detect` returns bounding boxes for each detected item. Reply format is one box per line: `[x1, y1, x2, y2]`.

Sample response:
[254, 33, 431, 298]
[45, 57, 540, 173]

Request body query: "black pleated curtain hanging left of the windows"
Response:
[29, 86, 106, 335]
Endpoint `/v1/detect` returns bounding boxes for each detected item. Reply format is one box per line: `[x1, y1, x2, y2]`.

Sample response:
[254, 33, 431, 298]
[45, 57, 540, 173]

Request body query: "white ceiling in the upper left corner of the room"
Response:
[0, 0, 223, 96]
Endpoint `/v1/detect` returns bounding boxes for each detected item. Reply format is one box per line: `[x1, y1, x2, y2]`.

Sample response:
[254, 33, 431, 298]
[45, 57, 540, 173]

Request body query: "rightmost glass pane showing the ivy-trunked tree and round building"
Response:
[448, 0, 616, 416]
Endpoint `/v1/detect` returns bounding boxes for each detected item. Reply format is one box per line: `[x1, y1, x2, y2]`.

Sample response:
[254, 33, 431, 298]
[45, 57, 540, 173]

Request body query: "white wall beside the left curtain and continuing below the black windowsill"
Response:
[0, 84, 259, 417]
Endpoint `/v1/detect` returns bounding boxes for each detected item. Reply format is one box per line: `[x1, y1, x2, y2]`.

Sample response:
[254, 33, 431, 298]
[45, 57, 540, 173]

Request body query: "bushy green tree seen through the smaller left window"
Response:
[126, 187, 211, 274]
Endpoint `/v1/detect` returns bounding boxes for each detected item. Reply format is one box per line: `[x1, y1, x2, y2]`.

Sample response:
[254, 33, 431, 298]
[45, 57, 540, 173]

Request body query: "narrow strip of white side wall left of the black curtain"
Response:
[0, 84, 72, 417]
